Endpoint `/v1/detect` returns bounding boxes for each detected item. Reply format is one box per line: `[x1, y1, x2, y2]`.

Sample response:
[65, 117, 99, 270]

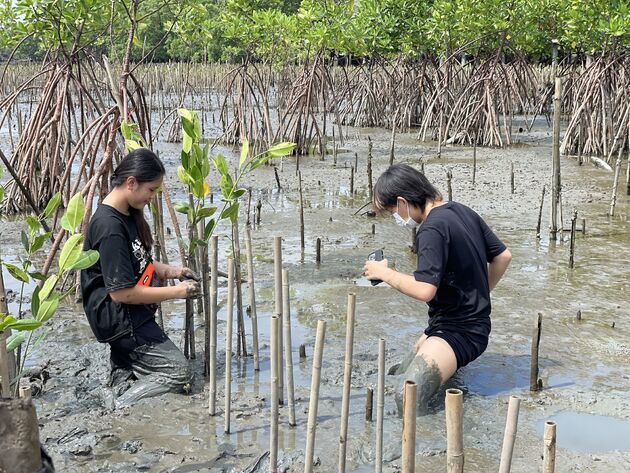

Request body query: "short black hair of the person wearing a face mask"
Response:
[373, 164, 442, 212]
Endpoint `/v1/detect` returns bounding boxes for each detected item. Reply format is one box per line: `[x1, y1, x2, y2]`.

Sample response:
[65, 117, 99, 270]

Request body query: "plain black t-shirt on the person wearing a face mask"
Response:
[414, 202, 506, 335]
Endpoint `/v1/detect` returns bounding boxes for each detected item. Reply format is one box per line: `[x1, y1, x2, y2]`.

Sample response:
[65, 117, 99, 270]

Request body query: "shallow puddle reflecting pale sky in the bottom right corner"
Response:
[536, 411, 630, 453]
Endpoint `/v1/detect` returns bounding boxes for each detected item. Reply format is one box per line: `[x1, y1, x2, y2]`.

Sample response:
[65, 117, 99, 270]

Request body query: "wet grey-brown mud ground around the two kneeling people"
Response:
[2, 120, 630, 473]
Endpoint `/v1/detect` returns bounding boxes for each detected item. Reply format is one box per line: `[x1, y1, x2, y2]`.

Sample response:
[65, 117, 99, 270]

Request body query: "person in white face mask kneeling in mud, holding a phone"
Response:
[363, 164, 512, 413]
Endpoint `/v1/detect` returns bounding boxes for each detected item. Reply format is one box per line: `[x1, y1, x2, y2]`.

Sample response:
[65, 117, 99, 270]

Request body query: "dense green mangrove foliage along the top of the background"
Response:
[0, 0, 630, 62]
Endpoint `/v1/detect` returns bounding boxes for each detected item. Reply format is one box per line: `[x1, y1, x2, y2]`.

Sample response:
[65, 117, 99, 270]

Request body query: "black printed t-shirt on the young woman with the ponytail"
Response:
[81, 204, 157, 342]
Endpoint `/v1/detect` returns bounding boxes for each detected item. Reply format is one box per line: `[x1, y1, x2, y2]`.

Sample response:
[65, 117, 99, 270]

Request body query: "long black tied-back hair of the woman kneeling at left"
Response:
[109, 148, 166, 251]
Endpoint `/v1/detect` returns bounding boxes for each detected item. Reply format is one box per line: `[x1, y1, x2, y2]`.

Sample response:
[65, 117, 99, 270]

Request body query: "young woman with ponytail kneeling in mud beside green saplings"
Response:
[81, 148, 200, 405]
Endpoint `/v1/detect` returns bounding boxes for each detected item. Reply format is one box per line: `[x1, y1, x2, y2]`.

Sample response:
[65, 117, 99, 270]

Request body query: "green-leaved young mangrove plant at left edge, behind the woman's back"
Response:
[0, 193, 99, 390]
